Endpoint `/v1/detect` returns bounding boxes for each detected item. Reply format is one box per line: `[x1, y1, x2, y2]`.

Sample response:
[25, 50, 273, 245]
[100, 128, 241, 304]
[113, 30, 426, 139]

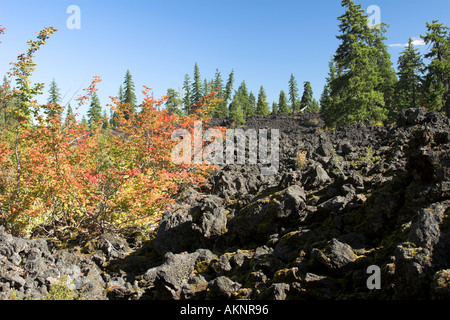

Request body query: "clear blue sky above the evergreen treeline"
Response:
[0, 0, 450, 117]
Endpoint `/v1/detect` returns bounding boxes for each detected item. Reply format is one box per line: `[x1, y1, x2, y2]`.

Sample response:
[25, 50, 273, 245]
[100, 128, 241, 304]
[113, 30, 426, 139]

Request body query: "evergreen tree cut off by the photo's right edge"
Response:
[421, 20, 450, 117]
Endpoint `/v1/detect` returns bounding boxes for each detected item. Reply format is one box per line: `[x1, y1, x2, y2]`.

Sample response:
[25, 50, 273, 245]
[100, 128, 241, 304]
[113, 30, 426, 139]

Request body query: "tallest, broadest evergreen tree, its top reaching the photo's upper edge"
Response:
[325, 0, 387, 126]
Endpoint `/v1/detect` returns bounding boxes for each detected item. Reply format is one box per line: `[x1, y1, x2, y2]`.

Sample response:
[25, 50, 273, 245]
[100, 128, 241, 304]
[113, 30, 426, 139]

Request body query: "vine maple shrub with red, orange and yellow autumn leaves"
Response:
[0, 28, 219, 234]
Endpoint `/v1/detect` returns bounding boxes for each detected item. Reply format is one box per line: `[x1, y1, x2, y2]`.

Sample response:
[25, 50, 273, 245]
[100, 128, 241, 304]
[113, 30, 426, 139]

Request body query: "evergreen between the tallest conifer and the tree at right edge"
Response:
[390, 38, 424, 118]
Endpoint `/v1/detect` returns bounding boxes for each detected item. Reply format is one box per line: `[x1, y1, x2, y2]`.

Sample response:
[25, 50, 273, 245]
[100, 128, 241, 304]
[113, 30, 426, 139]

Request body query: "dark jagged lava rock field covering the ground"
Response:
[0, 109, 450, 300]
